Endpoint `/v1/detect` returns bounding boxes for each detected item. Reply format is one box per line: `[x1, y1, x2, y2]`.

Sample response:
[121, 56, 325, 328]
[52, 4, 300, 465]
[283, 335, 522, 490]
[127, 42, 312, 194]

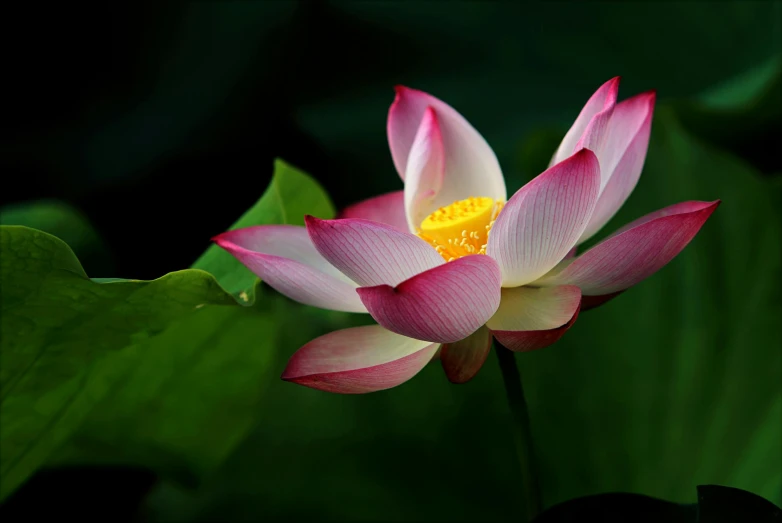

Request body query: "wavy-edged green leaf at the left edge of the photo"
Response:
[0, 226, 234, 498]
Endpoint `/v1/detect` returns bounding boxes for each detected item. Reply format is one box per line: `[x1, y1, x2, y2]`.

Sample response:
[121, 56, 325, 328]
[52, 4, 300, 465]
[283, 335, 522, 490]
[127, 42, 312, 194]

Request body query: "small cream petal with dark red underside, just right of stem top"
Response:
[486, 285, 581, 352]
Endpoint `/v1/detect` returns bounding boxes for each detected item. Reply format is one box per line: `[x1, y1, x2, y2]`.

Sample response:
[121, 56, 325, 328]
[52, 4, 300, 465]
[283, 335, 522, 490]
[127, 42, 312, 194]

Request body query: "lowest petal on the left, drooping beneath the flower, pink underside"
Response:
[282, 325, 439, 394]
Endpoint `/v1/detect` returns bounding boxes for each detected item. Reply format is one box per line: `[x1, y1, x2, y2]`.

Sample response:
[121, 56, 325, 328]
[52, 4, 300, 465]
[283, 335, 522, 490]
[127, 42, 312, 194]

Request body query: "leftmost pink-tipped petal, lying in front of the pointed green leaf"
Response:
[213, 225, 366, 312]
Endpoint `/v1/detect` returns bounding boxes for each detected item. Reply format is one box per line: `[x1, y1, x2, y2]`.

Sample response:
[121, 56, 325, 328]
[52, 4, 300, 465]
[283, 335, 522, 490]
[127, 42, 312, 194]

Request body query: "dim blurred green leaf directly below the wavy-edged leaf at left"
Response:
[49, 286, 279, 486]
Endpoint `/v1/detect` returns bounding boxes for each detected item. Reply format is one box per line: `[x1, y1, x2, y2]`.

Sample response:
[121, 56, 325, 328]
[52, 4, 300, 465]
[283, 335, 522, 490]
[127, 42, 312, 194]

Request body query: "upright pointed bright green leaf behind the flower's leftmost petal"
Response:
[193, 159, 335, 303]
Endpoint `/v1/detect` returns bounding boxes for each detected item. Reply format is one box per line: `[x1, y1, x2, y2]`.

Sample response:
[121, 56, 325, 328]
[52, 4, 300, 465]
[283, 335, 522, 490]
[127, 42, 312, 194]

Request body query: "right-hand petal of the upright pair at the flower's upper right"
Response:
[578, 91, 656, 243]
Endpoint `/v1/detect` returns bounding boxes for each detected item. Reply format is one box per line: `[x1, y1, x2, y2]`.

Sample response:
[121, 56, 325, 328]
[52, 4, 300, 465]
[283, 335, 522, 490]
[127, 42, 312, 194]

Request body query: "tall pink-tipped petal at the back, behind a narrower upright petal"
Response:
[387, 86, 507, 205]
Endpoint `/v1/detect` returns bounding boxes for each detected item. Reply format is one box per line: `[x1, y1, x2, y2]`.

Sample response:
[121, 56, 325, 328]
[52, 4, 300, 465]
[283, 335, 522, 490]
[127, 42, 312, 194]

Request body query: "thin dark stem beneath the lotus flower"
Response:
[494, 340, 540, 522]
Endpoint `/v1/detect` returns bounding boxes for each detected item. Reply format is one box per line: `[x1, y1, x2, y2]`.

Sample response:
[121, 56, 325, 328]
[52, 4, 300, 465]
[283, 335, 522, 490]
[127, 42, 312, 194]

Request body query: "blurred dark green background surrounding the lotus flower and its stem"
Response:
[0, 0, 782, 521]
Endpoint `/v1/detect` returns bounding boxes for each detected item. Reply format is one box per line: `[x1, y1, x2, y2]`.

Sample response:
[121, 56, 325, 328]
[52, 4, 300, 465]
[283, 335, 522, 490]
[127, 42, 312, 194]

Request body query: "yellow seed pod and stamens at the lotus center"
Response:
[418, 197, 505, 261]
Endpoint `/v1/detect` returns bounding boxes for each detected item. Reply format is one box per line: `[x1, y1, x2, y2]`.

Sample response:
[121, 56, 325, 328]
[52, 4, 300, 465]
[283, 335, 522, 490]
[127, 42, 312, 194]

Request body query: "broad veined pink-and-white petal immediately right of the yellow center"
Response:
[486, 149, 600, 287]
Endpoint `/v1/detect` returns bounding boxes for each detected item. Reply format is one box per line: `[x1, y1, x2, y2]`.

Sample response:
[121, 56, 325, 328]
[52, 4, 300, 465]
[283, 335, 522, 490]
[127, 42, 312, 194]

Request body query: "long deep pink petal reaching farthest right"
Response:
[536, 200, 720, 296]
